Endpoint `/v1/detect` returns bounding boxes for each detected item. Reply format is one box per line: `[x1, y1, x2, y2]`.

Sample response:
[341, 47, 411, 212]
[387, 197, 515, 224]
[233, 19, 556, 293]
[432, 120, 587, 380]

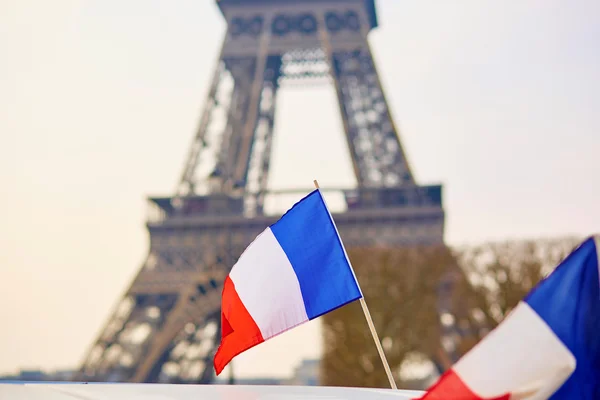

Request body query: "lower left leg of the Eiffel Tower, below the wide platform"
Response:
[75, 223, 237, 383]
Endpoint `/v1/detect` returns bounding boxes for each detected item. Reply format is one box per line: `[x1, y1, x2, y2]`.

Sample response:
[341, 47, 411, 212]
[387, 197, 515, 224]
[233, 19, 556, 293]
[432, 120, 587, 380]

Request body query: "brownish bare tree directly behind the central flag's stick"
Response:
[321, 246, 455, 387]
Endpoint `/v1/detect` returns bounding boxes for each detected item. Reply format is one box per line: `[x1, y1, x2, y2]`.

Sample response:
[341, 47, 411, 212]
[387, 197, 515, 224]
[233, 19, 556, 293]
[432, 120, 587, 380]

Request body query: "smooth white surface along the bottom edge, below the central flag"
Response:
[0, 383, 422, 400]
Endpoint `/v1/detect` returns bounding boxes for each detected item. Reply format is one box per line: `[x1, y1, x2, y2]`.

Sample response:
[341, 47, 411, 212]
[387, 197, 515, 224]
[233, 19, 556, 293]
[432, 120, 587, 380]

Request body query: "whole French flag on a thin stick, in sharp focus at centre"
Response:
[214, 189, 362, 375]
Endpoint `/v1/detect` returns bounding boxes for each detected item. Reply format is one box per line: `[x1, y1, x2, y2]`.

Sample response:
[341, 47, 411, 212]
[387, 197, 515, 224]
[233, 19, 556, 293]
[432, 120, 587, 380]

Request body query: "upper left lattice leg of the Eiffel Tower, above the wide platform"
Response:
[179, 29, 281, 216]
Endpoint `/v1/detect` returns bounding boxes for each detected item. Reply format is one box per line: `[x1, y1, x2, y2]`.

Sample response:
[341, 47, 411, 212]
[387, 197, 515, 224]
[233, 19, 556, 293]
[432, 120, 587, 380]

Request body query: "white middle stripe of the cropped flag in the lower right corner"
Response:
[453, 302, 575, 399]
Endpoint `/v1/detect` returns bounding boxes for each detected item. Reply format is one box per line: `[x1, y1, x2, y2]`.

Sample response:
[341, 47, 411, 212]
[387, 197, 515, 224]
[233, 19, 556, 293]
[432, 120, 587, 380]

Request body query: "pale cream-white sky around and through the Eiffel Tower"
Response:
[0, 0, 600, 376]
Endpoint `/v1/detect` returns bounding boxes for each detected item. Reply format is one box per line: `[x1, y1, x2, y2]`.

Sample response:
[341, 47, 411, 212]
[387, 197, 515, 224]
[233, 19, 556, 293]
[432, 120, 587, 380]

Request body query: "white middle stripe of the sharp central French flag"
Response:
[230, 228, 308, 340]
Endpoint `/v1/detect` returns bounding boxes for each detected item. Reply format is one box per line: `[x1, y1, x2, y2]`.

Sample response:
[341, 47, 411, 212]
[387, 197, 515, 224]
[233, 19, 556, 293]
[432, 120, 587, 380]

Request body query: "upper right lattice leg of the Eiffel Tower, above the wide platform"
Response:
[319, 13, 414, 187]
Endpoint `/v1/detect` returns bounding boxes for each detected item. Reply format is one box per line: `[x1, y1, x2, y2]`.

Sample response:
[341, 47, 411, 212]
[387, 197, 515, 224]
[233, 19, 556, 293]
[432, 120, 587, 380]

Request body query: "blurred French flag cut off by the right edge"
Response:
[421, 237, 600, 400]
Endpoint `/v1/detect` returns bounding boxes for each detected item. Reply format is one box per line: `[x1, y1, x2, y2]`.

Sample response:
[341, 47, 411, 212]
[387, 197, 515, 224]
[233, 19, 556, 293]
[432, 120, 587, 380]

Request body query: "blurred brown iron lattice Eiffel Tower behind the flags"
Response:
[75, 0, 444, 383]
